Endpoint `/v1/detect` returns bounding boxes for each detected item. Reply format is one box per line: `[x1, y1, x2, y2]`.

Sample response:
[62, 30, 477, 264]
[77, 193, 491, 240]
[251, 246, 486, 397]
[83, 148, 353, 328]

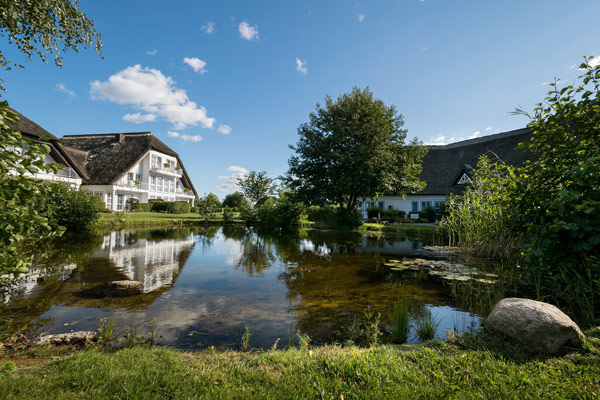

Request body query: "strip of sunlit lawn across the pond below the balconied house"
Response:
[96, 212, 241, 228]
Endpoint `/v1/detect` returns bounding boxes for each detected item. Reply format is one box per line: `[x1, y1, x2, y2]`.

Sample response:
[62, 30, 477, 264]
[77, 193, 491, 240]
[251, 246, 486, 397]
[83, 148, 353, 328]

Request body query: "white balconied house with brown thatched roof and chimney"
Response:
[60, 132, 197, 211]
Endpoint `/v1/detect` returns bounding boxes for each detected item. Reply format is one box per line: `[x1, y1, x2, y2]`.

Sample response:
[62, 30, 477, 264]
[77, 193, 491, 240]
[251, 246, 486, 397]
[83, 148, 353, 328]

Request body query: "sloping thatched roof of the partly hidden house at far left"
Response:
[8, 107, 86, 179]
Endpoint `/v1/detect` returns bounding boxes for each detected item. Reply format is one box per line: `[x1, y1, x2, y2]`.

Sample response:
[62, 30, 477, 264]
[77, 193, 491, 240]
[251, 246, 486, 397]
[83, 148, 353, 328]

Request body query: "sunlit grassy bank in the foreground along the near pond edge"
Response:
[0, 332, 600, 399]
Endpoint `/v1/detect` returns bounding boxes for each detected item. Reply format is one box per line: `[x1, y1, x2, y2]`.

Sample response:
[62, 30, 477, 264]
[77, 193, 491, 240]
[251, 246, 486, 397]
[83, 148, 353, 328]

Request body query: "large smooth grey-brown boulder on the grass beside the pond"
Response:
[485, 298, 584, 354]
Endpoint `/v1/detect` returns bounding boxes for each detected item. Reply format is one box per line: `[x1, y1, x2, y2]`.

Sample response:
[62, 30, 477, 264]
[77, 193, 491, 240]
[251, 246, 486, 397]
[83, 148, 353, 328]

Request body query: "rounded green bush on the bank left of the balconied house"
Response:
[37, 182, 104, 230]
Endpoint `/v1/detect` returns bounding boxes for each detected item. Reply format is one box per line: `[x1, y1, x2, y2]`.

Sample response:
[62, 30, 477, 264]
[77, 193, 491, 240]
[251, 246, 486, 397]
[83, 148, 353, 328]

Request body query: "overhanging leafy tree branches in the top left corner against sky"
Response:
[0, 0, 102, 90]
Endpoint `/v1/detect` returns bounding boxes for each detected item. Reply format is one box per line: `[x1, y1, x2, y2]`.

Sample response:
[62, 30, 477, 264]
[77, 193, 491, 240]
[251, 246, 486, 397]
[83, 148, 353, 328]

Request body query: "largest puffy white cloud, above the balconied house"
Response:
[90, 64, 215, 129]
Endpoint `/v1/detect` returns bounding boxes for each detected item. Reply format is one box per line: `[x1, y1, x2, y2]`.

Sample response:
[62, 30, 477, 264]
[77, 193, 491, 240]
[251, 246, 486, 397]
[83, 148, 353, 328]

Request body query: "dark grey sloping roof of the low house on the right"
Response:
[417, 128, 531, 195]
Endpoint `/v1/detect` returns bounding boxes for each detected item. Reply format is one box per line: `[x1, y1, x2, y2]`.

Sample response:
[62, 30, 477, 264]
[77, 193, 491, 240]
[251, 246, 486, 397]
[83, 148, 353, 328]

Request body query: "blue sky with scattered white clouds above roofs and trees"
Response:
[0, 0, 600, 198]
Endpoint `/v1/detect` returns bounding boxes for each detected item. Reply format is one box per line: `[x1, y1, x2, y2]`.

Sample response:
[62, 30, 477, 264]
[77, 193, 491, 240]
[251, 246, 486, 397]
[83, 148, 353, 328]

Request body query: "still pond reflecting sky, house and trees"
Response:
[0, 226, 488, 349]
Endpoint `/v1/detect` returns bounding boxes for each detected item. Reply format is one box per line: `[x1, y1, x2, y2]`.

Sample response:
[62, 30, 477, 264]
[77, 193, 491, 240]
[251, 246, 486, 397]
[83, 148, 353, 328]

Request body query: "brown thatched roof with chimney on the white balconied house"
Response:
[60, 132, 197, 195]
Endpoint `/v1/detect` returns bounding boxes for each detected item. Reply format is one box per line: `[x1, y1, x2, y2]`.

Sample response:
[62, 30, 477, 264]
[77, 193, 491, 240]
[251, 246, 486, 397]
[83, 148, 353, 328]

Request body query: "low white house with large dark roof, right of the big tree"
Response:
[360, 128, 531, 219]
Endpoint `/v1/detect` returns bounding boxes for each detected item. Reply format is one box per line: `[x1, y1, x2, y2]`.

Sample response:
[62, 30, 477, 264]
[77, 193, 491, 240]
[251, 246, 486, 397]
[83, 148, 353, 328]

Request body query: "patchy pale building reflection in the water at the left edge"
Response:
[0, 263, 77, 303]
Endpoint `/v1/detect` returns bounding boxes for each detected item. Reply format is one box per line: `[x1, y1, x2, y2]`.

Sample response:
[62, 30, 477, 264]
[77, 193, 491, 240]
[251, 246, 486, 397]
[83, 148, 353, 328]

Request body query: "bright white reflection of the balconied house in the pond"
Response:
[95, 232, 194, 293]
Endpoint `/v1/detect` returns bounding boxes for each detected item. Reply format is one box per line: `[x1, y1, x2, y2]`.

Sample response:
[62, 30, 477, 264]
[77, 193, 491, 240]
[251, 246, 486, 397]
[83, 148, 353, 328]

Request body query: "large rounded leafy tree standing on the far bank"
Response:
[285, 87, 427, 210]
